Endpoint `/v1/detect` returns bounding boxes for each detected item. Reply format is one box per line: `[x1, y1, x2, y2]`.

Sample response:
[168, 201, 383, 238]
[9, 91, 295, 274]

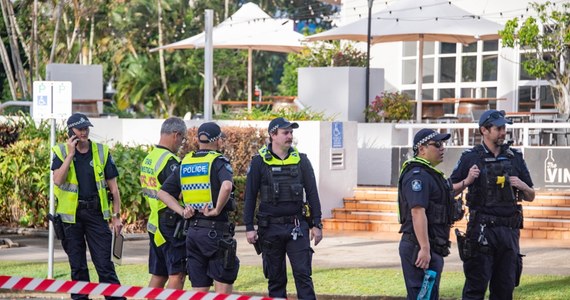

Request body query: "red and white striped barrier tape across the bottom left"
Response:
[0, 275, 273, 300]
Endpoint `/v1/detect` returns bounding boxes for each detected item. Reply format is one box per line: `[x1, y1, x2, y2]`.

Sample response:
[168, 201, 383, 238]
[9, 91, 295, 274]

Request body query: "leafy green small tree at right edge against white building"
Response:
[499, 2, 570, 113]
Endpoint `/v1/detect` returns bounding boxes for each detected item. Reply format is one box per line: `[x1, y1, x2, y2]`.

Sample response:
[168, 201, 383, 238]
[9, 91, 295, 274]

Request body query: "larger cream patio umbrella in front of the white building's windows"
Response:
[305, 0, 503, 121]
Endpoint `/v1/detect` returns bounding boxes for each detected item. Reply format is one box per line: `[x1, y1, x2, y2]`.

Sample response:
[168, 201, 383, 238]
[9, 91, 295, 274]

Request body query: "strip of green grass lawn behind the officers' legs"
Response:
[0, 261, 570, 300]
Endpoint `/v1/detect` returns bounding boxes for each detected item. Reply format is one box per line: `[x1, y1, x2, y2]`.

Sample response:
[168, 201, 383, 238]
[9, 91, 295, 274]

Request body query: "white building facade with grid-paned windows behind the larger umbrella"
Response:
[329, 0, 561, 113]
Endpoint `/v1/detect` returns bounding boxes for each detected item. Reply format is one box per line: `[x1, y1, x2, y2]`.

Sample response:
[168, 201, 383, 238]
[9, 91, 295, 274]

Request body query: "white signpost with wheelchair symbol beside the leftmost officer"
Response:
[32, 81, 71, 278]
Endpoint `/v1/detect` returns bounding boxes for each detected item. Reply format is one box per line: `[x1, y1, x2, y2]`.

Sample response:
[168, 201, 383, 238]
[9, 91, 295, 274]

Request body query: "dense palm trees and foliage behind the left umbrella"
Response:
[0, 0, 337, 117]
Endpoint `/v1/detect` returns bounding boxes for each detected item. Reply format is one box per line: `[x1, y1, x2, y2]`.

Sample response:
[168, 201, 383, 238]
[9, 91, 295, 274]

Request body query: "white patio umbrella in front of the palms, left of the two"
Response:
[150, 2, 303, 110]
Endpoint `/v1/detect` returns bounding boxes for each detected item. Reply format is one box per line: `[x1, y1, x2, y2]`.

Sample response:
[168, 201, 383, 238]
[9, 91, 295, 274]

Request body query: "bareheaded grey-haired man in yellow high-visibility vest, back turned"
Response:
[140, 117, 187, 289]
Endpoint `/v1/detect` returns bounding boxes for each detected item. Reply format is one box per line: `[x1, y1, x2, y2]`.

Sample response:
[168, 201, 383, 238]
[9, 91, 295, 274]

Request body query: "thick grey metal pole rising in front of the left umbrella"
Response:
[204, 9, 214, 121]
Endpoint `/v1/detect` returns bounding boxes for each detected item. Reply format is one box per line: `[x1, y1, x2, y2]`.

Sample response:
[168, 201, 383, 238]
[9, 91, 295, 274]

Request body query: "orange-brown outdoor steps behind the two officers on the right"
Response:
[323, 186, 570, 240]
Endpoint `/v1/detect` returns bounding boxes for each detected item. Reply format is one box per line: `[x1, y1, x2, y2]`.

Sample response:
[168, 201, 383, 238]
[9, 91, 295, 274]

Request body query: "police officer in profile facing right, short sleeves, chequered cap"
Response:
[398, 129, 462, 300]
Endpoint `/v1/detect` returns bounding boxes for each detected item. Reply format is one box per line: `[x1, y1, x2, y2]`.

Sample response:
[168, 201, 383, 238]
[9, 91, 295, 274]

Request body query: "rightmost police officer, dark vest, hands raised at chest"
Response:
[451, 110, 535, 299]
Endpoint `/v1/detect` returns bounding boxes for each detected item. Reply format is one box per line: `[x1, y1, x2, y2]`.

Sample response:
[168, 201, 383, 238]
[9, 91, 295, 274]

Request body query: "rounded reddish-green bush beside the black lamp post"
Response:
[364, 92, 413, 122]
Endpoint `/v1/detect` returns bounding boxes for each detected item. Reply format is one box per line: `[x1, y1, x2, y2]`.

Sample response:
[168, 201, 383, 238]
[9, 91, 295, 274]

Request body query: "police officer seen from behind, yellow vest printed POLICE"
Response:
[158, 122, 239, 294]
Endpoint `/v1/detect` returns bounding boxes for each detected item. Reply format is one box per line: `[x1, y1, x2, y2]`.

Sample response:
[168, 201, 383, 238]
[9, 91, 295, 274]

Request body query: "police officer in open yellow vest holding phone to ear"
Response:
[51, 113, 124, 299]
